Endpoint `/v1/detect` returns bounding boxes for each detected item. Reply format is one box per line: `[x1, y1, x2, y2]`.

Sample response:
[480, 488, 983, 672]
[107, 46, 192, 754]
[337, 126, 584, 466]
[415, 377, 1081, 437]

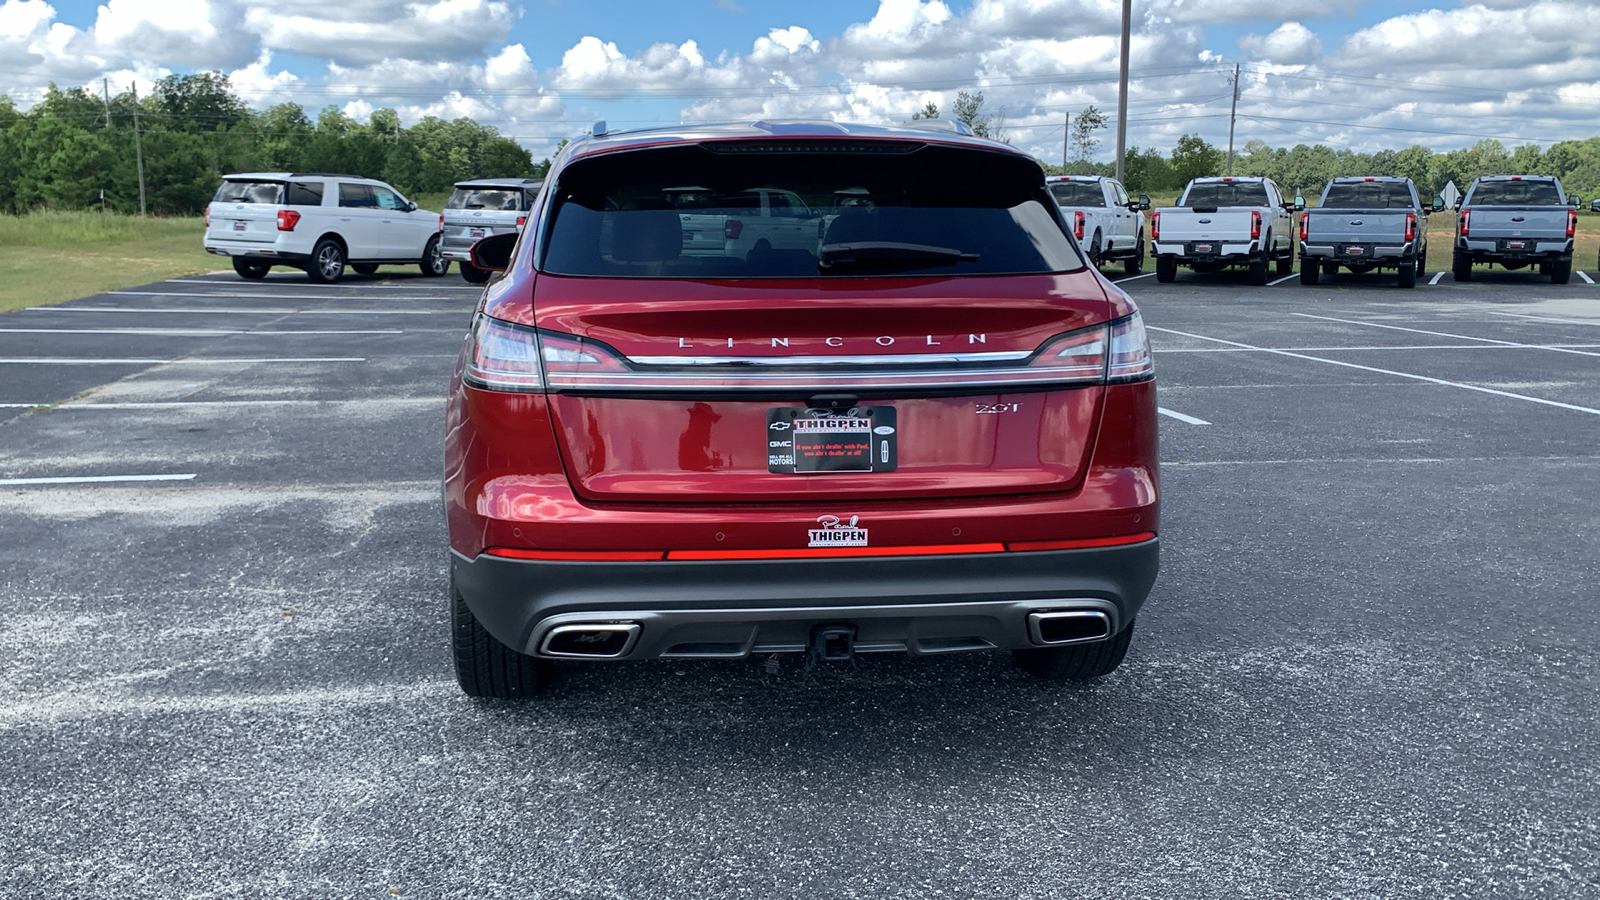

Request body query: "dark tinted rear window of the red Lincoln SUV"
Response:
[541, 143, 1083, 279]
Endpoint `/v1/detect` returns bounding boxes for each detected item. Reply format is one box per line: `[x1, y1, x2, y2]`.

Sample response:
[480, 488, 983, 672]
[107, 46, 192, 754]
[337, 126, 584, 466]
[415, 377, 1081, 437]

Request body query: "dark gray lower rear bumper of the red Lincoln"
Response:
[451, 540, 1158, 660]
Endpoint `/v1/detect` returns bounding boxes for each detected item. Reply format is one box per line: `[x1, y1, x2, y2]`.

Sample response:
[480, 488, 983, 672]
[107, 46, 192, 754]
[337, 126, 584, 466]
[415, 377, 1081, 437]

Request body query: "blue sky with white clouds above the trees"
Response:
[0, 0, 1600, 162]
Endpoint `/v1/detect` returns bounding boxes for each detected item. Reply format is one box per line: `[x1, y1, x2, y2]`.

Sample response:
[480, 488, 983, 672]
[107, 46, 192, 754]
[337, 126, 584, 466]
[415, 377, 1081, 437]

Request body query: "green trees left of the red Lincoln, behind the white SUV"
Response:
[0, 72, 547, 215]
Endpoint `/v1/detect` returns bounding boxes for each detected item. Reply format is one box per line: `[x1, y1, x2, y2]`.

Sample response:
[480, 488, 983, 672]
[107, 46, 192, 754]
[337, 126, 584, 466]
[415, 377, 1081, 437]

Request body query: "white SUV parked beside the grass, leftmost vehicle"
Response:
[205, 171, 450, 283]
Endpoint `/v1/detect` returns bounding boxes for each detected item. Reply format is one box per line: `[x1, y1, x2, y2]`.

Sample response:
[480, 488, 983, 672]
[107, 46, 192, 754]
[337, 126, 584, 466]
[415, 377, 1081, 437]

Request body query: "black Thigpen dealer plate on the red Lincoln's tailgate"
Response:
[766, 407, 899, 476]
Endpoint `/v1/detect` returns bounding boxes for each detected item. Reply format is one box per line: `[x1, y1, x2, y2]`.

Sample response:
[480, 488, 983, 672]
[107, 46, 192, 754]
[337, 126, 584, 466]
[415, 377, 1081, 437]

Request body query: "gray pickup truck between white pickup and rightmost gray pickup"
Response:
[1301, 176, 1445, 288]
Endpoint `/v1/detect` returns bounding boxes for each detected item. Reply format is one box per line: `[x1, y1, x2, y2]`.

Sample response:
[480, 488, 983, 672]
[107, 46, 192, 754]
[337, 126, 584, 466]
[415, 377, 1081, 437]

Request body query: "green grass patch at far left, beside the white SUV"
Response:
[0, 211, 219, 312]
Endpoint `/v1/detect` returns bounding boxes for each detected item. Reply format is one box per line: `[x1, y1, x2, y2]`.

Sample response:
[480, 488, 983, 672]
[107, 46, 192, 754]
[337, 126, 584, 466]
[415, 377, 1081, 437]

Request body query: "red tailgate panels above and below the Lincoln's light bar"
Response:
[534, 272, 1109, 503]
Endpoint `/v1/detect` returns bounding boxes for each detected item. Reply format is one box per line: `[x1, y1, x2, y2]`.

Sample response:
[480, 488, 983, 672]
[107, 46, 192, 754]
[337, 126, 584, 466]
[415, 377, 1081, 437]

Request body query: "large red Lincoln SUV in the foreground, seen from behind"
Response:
[445, 122, 1158, 697]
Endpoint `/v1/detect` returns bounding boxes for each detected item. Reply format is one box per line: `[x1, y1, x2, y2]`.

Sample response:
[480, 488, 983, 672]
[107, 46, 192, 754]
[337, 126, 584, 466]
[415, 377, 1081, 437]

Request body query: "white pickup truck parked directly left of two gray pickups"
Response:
[1150, 176, 1306, 285]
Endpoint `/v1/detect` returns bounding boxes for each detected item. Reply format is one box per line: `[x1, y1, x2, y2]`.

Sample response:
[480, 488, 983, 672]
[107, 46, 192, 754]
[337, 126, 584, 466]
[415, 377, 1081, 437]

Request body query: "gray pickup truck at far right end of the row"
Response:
[1450, 175, 1578, 285]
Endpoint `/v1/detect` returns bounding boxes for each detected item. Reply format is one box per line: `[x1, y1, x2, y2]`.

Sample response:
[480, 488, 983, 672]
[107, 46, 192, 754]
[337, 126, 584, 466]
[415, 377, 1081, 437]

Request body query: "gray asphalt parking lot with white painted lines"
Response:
[0, 259, 1600, 898]
